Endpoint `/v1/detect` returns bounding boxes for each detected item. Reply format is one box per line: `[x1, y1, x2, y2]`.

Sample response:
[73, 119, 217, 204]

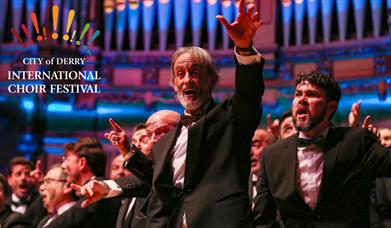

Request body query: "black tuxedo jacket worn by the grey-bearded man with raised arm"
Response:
[139, 60, 264, 228]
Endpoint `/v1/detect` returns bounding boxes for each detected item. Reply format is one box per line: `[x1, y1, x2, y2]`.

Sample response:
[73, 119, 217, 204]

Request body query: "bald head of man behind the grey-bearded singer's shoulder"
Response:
[146, 110, 181, 152]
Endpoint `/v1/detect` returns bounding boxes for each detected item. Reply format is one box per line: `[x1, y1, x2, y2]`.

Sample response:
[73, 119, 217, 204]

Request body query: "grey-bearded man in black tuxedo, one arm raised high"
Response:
[76, 0, 264, 228]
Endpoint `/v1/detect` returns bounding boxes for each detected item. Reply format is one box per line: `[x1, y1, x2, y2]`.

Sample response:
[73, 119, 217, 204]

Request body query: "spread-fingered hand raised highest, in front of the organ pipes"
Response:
[216, 0, 262, 48]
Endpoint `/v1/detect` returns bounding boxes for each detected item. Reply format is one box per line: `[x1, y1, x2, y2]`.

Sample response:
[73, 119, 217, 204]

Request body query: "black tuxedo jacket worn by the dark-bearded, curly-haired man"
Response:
[255, 128, 391, 228]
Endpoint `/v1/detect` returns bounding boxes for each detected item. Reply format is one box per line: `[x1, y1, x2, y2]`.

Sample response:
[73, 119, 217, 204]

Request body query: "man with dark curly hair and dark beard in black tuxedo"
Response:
[255, 71, 391, 227]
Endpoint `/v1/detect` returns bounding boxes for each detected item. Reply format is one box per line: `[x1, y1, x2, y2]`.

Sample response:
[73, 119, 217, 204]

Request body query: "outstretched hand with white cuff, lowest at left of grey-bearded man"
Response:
[71, 180, 108, 208]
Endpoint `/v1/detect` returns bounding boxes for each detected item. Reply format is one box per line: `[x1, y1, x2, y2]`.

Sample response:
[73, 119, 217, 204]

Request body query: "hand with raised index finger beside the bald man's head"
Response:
[104, 118, 130, 156]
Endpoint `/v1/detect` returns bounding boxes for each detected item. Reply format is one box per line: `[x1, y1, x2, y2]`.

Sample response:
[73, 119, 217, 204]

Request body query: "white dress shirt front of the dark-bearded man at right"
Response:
[296, 128, 328, 209]
